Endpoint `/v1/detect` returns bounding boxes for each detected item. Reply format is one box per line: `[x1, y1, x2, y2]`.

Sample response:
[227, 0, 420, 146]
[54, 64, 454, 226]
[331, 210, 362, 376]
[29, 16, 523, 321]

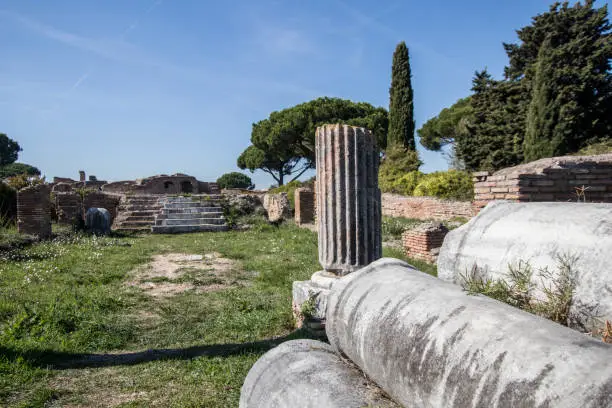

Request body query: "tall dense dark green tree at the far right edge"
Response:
[520, 1, 612, 161]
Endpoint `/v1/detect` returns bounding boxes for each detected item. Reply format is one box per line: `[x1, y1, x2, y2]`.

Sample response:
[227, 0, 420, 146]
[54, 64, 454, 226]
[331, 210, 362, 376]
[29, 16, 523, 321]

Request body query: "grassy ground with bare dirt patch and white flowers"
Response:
[0, 223, 434, 407]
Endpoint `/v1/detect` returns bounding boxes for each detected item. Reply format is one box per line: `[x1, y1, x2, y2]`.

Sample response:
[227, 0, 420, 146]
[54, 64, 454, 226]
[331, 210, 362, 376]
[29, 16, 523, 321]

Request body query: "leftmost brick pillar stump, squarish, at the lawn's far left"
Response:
[17, 184, 51, 238]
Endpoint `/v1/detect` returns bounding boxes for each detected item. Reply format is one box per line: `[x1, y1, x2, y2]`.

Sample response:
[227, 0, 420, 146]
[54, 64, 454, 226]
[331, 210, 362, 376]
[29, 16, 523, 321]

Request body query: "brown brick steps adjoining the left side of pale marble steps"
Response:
[113, 195, 163, 232]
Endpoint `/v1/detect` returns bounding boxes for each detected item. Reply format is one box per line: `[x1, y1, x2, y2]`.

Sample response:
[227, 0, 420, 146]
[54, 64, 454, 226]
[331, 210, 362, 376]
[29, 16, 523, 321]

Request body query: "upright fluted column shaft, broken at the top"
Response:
[316, 125, 382, 275]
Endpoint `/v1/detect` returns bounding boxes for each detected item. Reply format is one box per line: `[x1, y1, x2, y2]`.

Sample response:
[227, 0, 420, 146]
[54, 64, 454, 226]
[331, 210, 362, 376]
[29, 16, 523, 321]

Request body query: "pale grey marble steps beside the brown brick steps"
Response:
[152, 195, 228, 234]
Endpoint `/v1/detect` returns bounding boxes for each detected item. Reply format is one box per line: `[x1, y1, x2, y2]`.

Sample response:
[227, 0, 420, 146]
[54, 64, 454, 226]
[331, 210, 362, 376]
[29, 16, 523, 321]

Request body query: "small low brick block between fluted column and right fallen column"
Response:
[402, 223, 448, 263]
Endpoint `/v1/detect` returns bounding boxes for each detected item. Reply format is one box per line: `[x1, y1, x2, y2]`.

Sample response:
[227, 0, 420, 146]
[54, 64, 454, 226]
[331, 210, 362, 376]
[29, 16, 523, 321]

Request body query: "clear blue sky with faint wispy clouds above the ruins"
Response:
[0, 0, 580, 188]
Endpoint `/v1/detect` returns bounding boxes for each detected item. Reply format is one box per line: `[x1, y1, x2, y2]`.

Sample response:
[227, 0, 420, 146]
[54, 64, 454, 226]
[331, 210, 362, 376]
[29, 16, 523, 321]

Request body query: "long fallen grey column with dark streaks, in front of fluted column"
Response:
[327, 258, 612, 408]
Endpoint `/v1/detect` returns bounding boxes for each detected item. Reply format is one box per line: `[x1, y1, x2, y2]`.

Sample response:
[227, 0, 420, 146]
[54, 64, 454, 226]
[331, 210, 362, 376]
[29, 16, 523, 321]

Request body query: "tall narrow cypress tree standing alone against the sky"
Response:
[389, 41, 415, 150]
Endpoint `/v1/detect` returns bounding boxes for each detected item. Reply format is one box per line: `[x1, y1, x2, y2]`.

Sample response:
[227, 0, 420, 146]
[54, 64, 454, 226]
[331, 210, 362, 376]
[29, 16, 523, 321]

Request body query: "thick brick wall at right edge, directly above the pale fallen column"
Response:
[474, 154, 612, 209]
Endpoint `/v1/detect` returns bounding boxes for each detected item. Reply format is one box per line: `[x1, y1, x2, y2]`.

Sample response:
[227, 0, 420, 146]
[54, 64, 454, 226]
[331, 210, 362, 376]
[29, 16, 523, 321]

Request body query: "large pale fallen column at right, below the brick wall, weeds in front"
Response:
[438, 201, 612, 324]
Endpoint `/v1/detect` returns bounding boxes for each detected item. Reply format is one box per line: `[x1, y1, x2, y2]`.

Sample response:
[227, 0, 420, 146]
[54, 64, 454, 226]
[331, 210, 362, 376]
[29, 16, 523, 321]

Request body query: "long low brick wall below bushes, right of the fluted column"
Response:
[382, 193, 474, 221]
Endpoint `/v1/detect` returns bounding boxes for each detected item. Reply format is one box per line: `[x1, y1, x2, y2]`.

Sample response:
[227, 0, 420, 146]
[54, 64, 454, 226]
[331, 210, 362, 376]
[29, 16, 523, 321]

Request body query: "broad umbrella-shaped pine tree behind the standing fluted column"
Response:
[238, 98, 389, 186]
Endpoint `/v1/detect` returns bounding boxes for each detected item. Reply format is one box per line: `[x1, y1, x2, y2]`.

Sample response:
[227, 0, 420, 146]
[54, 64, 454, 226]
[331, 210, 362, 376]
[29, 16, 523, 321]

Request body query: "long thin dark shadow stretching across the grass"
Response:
[0, 330, 312, 370]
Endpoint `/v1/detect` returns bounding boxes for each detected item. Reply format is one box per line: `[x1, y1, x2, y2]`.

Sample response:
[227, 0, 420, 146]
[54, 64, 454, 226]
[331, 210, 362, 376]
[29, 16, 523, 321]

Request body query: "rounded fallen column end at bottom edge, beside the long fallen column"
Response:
[239, 340, 398, 408]
